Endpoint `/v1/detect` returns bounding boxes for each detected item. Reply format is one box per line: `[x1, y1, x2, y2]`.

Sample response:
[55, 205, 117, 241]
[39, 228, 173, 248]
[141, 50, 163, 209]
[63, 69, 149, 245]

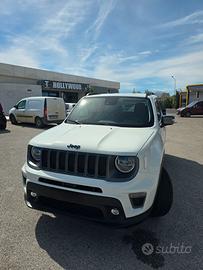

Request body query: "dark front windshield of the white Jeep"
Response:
[65, 96, 154, 127]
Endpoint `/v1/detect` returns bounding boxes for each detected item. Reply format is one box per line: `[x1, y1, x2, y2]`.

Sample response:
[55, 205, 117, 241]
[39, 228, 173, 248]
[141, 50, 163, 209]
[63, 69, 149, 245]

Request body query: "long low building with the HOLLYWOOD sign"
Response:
[0, 63, 120, 114]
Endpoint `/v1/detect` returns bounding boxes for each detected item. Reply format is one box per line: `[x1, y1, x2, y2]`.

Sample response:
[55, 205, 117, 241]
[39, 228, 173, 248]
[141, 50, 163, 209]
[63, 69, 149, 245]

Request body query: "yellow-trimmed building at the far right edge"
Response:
[179, 84, 203, 107]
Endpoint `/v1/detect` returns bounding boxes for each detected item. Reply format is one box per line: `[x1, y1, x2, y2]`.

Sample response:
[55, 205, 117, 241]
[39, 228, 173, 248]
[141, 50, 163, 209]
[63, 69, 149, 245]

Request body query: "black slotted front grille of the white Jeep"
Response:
[40, 149, 112, 179]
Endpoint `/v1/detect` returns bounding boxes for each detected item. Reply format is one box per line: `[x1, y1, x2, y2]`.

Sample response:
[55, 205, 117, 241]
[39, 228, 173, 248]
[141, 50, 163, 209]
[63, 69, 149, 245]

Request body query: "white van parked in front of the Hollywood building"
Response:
[9, 97, 66, 128]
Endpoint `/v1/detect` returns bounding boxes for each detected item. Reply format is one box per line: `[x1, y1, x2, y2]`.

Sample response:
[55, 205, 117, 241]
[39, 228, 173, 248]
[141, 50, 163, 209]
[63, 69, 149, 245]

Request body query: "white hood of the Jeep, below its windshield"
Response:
[30, 123, 155, 154]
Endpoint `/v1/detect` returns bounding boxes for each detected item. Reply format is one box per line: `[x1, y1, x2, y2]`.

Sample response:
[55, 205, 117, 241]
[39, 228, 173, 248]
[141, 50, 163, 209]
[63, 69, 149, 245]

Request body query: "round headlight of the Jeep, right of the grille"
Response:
[115, 156, 136, 173]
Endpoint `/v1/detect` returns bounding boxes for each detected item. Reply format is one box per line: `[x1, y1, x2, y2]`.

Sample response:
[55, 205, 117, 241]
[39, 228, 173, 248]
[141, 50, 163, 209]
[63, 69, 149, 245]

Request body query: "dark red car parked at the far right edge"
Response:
[177, 101, 203, 117]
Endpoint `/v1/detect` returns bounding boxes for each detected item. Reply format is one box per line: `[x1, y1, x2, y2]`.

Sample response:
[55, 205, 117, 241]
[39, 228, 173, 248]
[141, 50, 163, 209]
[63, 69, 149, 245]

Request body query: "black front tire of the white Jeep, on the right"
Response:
[151, 168, 173, 217]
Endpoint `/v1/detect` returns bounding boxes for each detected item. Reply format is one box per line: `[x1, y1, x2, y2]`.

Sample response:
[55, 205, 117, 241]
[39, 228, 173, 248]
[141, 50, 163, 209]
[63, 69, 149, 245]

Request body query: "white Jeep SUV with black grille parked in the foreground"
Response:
[22, 94, 173, 225]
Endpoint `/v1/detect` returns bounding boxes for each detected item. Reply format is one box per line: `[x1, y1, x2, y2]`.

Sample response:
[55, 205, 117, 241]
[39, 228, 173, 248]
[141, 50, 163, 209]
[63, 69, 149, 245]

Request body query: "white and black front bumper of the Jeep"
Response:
[22, 164, 157, 226]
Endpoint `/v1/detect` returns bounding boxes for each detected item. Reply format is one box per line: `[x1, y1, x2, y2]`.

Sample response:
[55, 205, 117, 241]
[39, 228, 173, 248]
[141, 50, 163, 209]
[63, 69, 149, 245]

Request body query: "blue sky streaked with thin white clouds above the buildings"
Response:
[0, 0, 203, 93]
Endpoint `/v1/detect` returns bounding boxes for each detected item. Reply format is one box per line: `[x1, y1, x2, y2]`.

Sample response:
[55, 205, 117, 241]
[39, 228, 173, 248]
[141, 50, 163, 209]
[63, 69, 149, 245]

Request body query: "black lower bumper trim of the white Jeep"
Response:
[25, 182, 149, 226]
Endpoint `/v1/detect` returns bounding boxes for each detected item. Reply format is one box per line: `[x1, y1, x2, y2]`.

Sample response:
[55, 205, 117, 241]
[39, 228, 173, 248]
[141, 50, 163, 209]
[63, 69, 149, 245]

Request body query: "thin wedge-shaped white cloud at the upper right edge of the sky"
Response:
[161, 10, 203, 27]
